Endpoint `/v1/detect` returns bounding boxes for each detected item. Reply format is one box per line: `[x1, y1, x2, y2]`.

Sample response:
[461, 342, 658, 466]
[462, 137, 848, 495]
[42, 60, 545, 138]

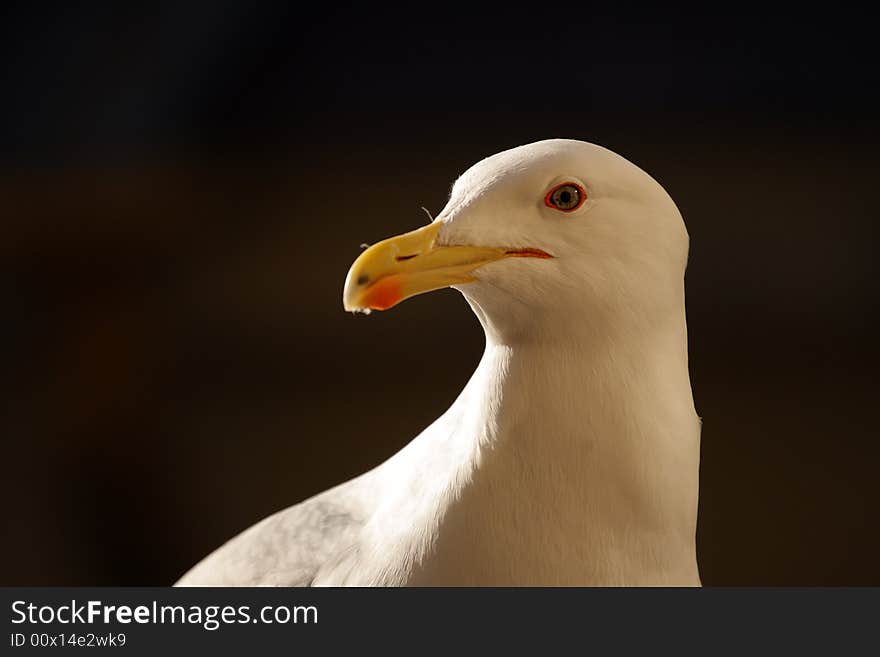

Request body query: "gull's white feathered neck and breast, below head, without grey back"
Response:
[348, 300, 700, 586]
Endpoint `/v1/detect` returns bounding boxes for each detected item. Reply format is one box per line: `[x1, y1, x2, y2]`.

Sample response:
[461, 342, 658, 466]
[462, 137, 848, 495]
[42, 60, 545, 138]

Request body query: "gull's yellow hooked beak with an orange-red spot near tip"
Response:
[342, 222, 552, 311]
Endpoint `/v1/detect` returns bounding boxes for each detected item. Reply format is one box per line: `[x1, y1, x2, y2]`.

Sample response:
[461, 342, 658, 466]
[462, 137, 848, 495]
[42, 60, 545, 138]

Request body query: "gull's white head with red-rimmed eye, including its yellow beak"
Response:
[343, 139, 688, 340]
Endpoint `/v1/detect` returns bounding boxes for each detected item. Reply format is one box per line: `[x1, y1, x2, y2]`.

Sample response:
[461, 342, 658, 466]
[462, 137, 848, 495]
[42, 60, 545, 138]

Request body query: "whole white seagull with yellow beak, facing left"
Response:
[178, 139, 701, 586]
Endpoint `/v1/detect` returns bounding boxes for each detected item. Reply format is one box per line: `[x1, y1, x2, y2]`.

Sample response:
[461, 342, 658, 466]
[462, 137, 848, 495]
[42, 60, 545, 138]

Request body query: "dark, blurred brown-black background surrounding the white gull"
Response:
[0, 1, 880, 585]
